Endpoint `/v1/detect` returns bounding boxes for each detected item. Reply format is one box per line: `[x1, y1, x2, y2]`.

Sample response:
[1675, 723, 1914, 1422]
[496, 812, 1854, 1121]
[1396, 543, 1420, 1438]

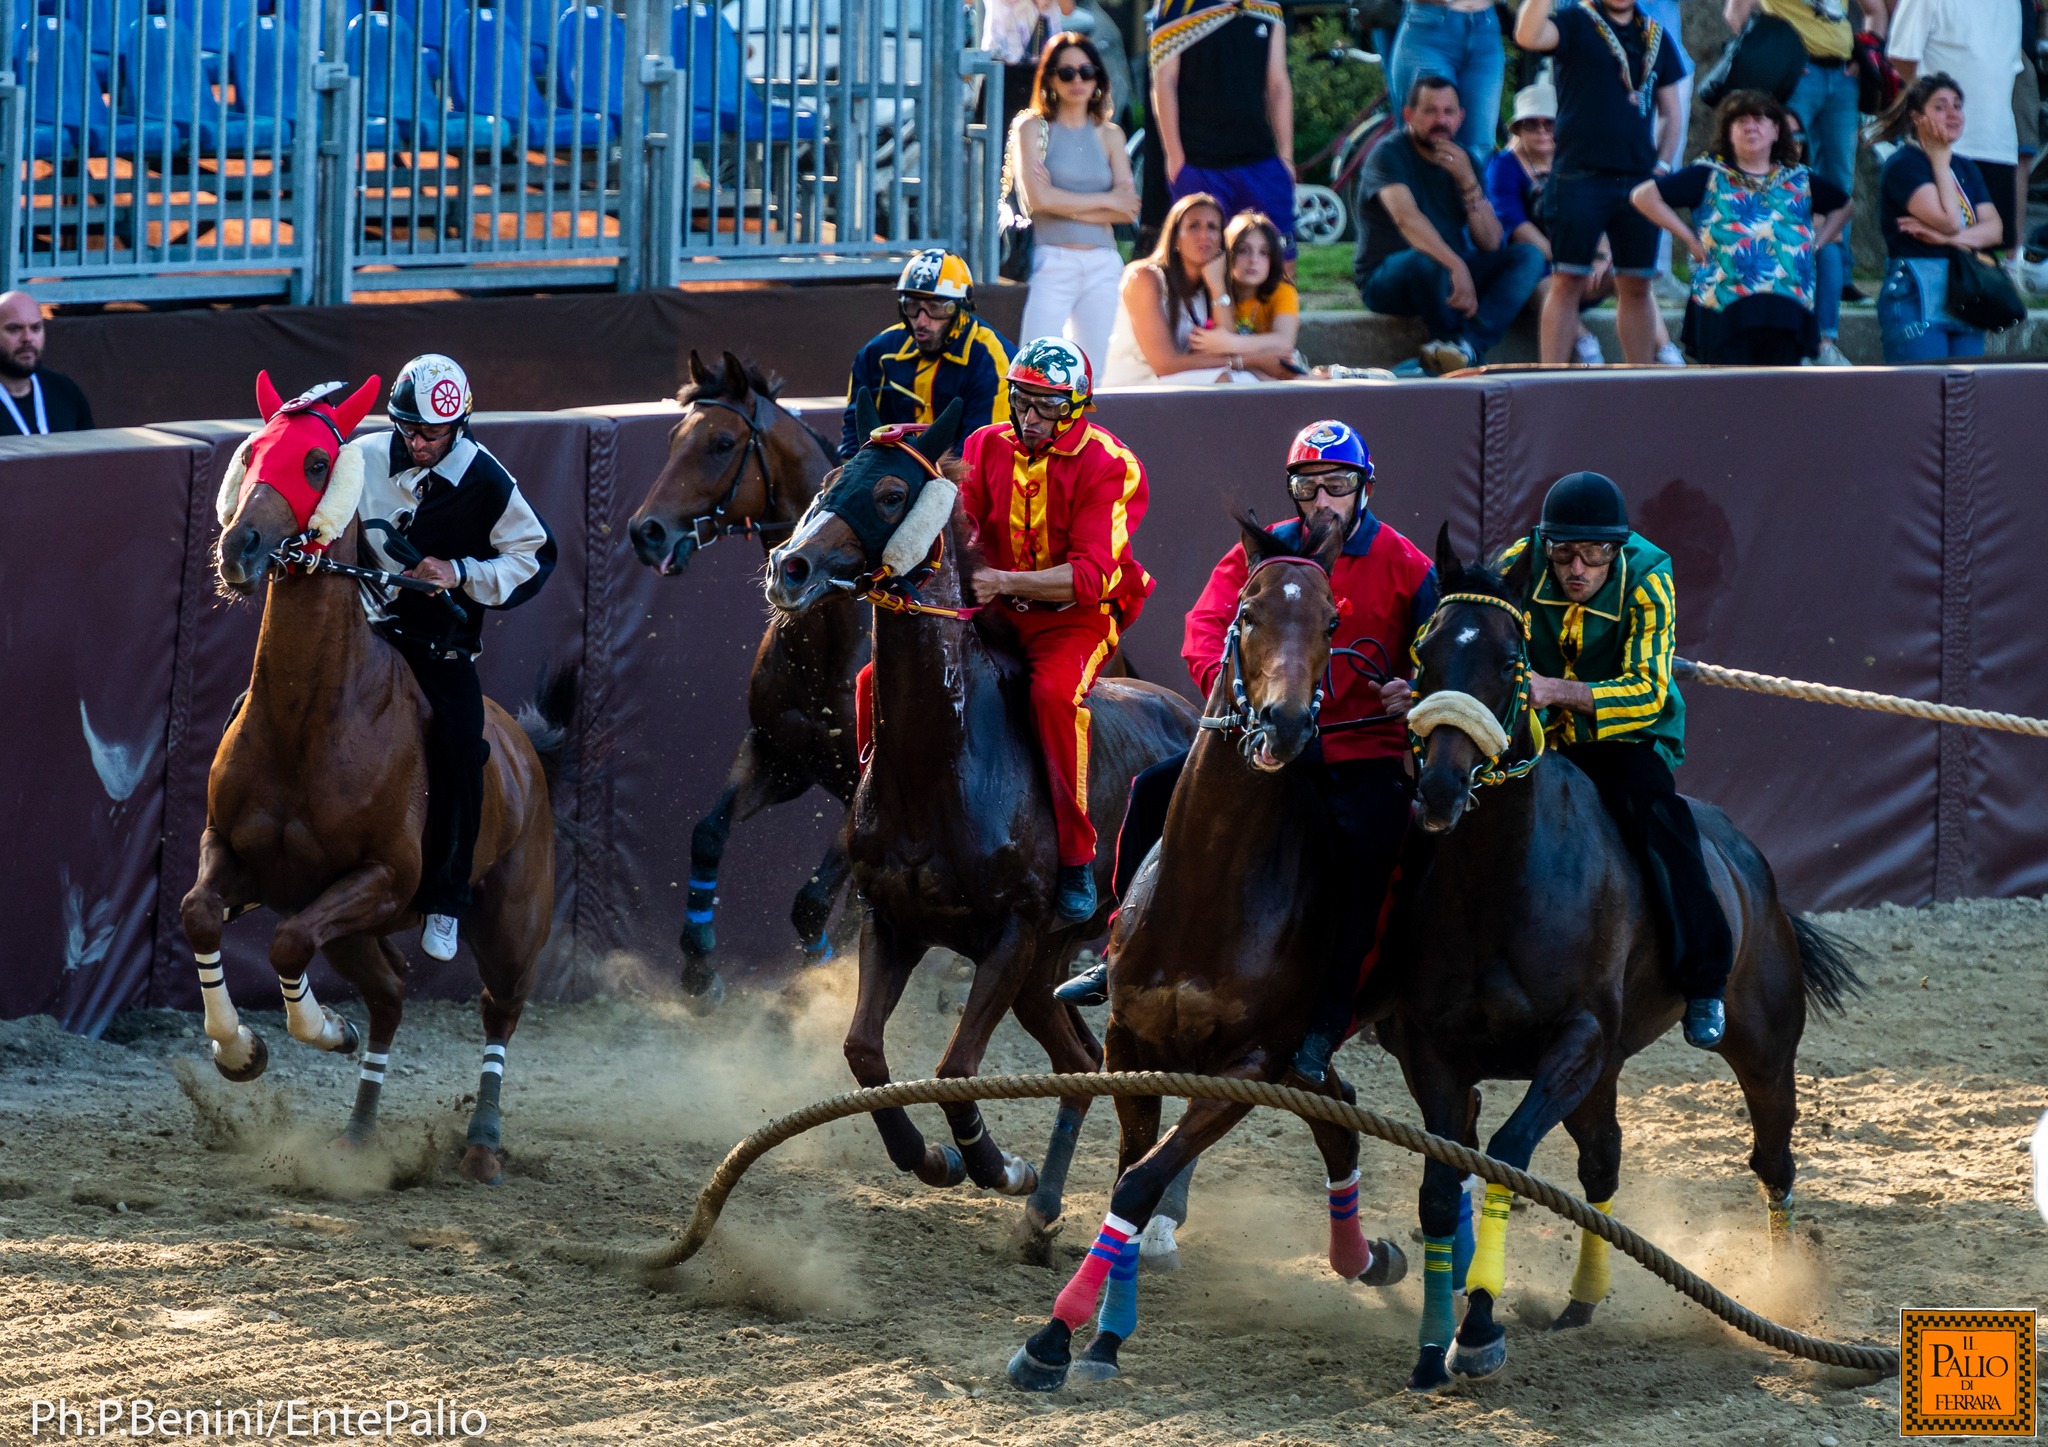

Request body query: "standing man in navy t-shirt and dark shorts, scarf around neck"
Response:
[1516, 0, 1686, 362]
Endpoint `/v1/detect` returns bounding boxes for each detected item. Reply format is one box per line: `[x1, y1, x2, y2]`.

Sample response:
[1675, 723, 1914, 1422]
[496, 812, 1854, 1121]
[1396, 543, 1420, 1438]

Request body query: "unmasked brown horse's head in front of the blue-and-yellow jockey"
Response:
[627, 352, 780, 575]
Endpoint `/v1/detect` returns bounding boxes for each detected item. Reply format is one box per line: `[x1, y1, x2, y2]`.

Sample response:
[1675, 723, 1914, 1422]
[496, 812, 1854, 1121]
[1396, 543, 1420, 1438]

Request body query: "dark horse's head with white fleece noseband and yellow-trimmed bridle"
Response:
[1409, 524, 1534, 833]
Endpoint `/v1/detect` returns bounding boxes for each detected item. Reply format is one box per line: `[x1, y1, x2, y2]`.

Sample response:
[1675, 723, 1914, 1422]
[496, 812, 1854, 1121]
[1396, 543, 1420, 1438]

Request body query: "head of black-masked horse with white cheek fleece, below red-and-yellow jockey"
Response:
[768, 391, 963, 612]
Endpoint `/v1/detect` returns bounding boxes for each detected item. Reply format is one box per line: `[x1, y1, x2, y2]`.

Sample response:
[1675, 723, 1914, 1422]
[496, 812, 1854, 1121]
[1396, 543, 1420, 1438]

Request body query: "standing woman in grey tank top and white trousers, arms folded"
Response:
[1008, 31, 1139, 379]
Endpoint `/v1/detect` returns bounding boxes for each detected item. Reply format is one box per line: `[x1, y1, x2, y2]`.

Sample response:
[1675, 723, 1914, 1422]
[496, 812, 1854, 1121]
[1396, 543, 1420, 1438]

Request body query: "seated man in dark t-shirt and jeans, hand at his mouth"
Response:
[1352, 74, 1544, 377]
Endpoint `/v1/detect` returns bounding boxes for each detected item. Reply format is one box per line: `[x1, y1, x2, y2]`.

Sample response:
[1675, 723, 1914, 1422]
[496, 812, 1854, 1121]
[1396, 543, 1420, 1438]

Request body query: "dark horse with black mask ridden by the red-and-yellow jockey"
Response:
[768, 393, 1194, 1226]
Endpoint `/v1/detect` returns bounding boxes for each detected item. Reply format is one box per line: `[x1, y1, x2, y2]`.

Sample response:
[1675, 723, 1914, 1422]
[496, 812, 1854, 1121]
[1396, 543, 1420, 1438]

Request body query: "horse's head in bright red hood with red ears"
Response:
[215, 372, 383, 594]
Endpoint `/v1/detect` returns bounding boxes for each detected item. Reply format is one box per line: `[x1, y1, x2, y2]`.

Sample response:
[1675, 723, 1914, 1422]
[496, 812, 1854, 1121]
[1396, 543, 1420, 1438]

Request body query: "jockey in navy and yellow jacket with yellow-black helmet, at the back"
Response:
[840, 248, 1012, 463]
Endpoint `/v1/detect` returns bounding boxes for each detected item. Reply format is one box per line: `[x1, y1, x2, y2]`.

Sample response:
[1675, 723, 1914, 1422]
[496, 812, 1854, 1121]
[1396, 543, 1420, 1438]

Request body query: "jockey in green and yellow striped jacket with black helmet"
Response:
[1495, 473, 1735, 1050]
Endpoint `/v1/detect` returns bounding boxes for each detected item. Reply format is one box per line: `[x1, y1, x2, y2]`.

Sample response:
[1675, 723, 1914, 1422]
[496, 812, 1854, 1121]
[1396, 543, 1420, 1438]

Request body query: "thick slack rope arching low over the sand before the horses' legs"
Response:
[555, 1070, 1898, 1375]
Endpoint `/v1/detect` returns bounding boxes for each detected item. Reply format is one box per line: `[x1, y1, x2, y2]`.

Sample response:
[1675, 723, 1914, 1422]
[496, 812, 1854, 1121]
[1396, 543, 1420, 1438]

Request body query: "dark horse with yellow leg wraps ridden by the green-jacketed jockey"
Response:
[1378, 528, 1862, 1390]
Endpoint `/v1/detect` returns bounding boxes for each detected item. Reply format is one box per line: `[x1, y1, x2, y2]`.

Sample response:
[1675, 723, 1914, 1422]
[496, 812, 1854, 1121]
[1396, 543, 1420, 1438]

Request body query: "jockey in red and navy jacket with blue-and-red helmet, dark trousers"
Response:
[1057, 420, 1438, 1081]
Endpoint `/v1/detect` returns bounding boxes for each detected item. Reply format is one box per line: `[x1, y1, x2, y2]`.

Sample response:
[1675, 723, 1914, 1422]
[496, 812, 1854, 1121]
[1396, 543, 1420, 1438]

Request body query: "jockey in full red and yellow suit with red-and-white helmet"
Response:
[961, 338, 1153, 923]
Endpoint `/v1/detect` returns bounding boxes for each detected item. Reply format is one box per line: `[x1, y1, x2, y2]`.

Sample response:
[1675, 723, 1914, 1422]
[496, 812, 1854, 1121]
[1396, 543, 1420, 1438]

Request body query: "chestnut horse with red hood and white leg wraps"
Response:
[182, 375, 559, 1183]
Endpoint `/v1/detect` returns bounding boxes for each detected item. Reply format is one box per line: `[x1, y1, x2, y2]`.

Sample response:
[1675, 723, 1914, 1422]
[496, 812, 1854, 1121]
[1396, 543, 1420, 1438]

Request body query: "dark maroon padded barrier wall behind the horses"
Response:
[0, 366, 2048, 1029]
